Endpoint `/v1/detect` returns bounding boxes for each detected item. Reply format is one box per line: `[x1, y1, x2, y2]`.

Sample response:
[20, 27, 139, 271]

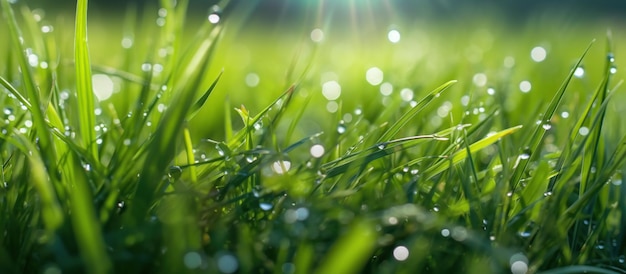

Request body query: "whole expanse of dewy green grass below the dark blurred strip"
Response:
[0, 0, 626, 273]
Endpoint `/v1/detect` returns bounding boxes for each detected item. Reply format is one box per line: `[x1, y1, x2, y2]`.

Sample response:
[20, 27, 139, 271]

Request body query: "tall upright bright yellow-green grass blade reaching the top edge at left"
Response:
[74, 0, 98, 159]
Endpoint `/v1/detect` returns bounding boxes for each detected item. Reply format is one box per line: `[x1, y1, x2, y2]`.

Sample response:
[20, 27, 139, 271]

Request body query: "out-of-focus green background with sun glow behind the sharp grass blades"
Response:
[0, 0, 626, 139]
